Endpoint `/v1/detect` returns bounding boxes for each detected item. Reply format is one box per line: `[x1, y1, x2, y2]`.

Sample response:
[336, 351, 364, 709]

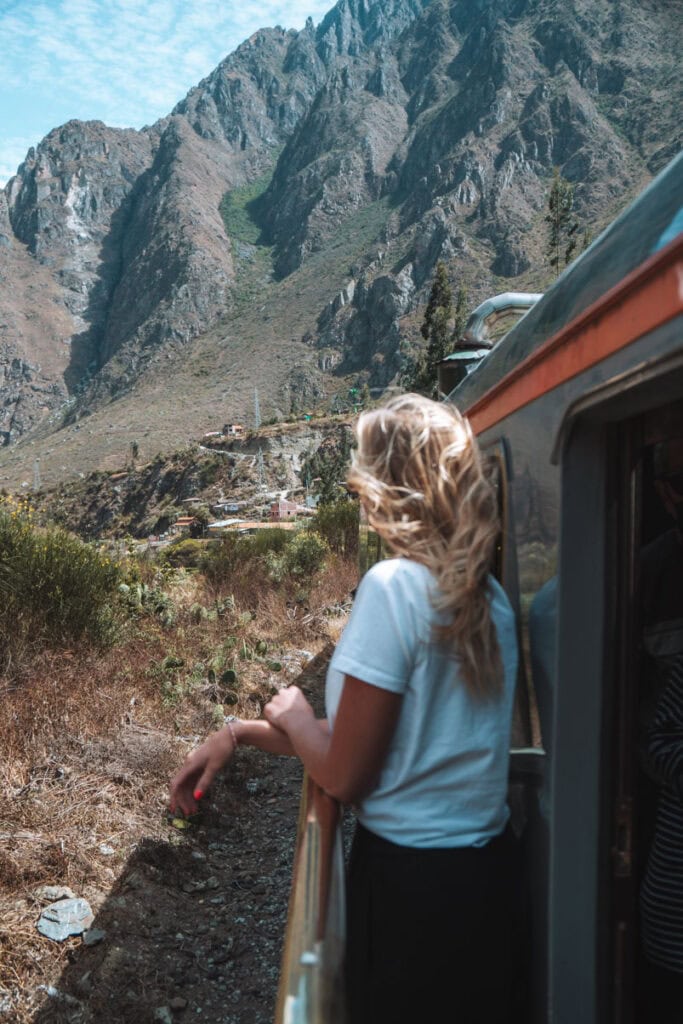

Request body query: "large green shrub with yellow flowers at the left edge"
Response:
[0, 502, 121, 668]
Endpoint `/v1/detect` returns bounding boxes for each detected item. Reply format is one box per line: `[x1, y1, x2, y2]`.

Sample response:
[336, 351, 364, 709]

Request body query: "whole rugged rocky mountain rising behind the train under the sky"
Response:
[0, 0, 683, 484]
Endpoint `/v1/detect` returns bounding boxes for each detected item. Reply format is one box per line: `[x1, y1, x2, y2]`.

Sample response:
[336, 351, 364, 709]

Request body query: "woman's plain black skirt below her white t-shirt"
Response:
[346, 825, 523, 1024]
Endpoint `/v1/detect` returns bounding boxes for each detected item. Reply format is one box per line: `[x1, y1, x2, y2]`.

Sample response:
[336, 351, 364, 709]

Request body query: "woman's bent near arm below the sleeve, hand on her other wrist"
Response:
[263, 676, 402, 804]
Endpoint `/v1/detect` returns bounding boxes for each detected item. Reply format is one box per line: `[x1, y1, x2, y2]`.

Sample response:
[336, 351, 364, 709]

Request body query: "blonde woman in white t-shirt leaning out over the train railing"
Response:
[171, 394, 517, 1024]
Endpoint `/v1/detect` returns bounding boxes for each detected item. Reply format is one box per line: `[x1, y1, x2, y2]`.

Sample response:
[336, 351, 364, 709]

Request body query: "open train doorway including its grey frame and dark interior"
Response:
[548, 382, 683, 1024]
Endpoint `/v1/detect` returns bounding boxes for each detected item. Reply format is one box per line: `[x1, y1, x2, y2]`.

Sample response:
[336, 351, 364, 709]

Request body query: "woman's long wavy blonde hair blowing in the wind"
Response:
[348, 394, 503, 698]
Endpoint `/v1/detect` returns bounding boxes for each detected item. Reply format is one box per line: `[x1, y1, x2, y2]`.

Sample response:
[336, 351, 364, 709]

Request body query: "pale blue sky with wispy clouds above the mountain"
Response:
[0, 0, 334, 187]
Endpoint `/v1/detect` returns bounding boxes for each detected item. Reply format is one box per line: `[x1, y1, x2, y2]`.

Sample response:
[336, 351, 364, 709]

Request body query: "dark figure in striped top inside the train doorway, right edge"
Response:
[639, 438, 683, 1024]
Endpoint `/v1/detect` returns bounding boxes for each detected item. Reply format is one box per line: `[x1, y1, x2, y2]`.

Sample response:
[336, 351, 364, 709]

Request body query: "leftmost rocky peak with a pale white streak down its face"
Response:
[0, 121, 153, 443]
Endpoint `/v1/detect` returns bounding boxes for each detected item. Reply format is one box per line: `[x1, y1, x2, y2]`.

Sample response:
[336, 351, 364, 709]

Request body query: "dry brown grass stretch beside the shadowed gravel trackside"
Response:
[0, 558, 355, 1024]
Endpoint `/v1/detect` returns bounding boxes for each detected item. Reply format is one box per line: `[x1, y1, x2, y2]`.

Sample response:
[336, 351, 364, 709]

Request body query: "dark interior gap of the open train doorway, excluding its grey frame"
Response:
[609, 401, 683, 1024]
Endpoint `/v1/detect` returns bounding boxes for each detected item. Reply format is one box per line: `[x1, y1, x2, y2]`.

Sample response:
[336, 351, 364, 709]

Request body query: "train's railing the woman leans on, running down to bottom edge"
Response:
[275, 775, 346, 1024]
